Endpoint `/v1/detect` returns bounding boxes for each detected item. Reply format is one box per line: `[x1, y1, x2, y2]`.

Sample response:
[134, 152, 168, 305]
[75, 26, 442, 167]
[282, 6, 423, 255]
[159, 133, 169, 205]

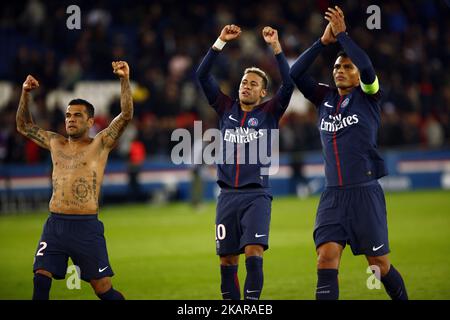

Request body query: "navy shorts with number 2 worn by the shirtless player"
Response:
[33, 213, 114, 282]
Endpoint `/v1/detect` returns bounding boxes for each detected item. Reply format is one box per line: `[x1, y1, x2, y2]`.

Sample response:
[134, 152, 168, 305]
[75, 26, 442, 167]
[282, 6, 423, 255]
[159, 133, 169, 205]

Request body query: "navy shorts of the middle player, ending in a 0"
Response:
[216, 188, 272, 256]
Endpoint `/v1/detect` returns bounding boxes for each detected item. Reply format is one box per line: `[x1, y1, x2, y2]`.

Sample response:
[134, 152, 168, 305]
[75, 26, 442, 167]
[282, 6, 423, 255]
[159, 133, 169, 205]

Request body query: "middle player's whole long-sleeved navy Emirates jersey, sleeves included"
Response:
[197, 49, 294, 188]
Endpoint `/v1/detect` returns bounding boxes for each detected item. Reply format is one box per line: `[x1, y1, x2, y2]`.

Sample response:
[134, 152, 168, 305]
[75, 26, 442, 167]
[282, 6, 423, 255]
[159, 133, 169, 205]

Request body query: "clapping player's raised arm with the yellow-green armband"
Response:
[325, 6, 379, 94]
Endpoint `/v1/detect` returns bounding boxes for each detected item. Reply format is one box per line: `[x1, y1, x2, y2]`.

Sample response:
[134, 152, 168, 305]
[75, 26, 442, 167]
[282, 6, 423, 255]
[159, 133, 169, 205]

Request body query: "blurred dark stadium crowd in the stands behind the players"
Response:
[0, 0, 450, 163]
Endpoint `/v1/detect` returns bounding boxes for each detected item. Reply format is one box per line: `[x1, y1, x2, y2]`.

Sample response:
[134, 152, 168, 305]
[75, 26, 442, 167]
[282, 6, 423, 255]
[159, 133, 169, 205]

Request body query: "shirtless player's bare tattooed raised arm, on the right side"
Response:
[99, 61, 133, 149]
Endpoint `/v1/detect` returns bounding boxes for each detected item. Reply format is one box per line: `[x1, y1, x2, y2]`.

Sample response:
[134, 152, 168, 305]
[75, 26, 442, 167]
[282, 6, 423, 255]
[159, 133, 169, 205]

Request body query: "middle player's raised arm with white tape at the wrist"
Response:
[196, 24, 241, 105]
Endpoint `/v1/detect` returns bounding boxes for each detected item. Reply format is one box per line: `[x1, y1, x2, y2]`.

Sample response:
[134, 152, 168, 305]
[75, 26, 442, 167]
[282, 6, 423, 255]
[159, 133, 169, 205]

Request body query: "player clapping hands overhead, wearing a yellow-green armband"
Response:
[290, 6, 408, 300]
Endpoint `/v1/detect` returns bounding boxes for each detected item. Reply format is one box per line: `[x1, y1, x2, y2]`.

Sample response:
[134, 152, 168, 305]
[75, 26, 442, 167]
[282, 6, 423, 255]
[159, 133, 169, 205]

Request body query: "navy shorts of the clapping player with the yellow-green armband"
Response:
[314, 180, 389, 256]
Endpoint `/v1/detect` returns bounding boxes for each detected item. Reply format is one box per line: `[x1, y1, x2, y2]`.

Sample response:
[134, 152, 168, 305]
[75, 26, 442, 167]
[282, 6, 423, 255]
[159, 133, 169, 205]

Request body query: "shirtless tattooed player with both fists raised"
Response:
[16, 61, 133, 300]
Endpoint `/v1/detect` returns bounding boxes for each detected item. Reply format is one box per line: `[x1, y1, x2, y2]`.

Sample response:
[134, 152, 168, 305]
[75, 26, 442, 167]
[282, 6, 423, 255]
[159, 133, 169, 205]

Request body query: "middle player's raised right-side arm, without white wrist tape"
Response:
[262, 27, 294, 110]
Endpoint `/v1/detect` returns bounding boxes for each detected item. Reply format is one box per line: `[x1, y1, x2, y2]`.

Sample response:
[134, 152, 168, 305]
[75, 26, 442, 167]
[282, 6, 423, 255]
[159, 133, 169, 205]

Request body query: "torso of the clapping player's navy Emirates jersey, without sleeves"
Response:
[306, 84, 387, 186]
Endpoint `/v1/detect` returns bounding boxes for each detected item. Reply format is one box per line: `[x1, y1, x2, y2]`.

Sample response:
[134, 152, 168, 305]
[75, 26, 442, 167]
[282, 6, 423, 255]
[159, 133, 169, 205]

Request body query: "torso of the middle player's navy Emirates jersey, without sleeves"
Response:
[213, 92, 285, 188]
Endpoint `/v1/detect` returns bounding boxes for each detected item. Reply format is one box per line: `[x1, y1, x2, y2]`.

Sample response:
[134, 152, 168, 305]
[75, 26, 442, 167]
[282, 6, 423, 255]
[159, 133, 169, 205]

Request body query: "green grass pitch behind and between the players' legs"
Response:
[0, 191, 450, 300]
